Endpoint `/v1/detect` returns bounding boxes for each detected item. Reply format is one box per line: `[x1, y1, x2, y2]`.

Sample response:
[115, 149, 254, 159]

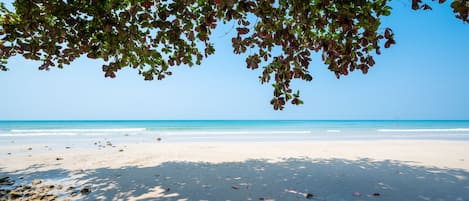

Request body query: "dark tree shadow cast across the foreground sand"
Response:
[0, 158, 469, 201]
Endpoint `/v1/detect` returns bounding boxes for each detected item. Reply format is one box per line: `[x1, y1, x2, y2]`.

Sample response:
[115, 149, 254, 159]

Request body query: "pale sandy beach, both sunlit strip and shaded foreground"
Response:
[0, 140, 469, 201]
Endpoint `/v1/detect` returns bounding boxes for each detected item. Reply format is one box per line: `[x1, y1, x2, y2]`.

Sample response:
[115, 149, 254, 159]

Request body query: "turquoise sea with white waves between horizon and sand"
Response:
[0, 120, 469, 146]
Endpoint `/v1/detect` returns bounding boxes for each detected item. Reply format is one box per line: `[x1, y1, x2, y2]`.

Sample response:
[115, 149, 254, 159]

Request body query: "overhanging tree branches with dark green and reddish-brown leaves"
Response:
[0, 0, 469, 110]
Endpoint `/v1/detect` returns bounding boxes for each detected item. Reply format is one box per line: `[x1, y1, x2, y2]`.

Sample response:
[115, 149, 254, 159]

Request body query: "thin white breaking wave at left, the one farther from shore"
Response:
[10, 128, 147, 133]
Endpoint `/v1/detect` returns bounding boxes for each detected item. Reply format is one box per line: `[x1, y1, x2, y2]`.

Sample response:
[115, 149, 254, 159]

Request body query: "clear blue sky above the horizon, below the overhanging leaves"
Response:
[0, 0, 469, 120]
